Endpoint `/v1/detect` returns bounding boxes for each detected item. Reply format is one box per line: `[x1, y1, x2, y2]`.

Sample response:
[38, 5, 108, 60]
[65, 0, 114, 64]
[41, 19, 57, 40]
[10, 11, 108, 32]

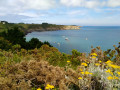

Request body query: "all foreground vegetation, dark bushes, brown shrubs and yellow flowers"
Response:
[0, 23, 120, 90]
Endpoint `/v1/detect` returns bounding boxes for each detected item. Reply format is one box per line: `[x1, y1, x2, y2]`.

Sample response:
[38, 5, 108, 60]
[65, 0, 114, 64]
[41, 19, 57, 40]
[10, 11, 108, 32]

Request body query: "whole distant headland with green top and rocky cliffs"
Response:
[0, 21, 81, 34]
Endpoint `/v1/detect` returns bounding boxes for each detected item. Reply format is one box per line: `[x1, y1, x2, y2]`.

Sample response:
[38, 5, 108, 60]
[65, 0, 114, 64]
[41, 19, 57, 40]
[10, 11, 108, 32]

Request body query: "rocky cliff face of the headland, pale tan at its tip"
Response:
[27, 25, 80, 33]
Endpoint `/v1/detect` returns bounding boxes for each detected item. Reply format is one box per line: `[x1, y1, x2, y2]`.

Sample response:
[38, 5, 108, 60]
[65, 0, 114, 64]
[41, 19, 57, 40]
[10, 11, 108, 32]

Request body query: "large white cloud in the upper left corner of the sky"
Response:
[0, 0, 56, 15]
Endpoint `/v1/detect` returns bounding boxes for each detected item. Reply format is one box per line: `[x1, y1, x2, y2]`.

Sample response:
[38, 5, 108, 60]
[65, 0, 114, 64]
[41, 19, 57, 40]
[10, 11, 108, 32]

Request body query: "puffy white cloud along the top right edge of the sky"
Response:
[60, 0, 120, 8]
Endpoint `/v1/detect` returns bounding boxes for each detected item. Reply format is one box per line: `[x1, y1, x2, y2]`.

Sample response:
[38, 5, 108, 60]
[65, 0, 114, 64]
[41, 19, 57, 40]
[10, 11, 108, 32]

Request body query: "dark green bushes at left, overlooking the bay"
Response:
[0, 27, 52, 50]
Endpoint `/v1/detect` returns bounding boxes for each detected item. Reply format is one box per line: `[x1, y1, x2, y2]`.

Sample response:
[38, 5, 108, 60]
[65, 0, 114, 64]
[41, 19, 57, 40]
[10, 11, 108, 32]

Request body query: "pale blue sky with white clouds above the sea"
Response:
[0, 0, 120, 26]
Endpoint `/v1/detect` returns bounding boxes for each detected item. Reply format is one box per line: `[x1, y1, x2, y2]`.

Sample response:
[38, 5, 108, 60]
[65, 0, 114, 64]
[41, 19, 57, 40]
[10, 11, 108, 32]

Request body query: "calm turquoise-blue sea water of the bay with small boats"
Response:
[26, 26, 120, 54]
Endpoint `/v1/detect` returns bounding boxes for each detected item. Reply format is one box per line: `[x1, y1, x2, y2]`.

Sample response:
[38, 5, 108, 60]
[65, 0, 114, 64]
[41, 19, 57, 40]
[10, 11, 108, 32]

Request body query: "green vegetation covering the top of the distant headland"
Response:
[0, 23, 64, 34]
